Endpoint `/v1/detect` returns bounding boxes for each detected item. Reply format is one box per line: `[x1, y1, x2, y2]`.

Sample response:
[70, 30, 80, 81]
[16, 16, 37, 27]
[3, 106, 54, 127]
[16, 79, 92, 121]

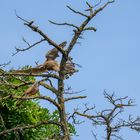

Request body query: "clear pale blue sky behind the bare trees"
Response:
[0, 0, 140, 140]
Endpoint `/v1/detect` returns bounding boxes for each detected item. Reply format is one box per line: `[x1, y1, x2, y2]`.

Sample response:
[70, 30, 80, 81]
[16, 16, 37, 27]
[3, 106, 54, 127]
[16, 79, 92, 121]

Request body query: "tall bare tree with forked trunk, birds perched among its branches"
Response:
[0, 0, 114, 140]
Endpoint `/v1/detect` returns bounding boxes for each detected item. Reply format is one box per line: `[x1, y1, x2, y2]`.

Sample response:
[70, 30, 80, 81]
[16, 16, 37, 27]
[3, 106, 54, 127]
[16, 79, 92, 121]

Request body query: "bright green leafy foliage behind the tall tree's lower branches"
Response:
[0, 76, 75, 140]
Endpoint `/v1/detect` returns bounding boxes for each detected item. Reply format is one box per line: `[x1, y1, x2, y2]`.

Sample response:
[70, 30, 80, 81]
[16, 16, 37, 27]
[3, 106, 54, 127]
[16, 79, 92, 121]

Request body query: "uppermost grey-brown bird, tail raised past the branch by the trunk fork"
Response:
[45, 41, 67, 61]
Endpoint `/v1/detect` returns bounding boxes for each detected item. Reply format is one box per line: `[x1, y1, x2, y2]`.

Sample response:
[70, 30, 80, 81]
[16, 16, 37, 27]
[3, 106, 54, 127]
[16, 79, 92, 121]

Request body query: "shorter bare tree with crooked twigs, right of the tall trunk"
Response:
[73, 92, 140, 140]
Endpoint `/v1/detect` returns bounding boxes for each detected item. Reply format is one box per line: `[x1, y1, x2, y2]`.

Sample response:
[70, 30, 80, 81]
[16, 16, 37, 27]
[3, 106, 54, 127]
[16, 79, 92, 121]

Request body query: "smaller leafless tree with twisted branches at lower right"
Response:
[70, 91, 140, 140]
